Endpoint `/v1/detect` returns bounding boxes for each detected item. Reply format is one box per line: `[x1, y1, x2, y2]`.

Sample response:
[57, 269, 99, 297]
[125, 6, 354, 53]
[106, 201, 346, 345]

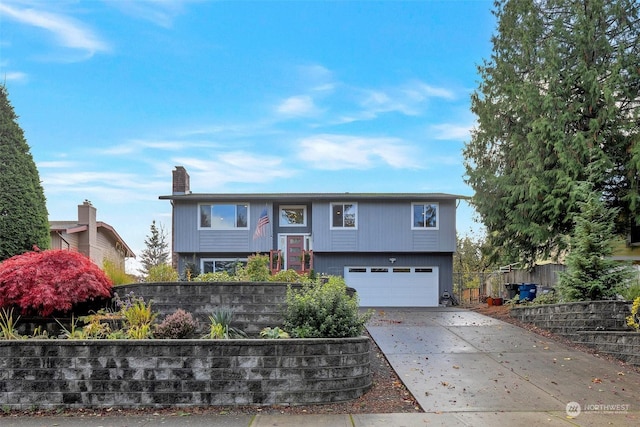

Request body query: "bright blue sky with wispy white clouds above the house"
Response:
[0, 0, 495, 272]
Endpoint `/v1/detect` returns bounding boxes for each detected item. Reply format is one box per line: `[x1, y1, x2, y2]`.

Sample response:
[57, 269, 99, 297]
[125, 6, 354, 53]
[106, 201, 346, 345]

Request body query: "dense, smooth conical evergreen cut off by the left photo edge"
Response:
[0, 85, 51, 261]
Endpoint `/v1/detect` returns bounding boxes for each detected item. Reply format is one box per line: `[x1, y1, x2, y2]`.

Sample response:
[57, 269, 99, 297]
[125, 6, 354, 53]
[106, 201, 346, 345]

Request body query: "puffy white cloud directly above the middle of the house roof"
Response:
[297, 134, 420, 170]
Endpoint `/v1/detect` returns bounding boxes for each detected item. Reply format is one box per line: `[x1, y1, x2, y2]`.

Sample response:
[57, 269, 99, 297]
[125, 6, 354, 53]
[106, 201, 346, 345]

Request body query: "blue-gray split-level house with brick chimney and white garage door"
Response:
[160, 166, 464, 306]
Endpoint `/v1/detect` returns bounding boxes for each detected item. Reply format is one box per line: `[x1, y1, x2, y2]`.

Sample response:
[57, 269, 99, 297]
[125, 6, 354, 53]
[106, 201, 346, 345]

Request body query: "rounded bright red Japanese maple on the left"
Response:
[0, 250, 112, 316]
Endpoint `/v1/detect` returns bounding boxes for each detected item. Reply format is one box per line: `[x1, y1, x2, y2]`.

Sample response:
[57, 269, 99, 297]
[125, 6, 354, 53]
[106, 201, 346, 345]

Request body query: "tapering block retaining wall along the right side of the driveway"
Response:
[511, 301, 640, 365]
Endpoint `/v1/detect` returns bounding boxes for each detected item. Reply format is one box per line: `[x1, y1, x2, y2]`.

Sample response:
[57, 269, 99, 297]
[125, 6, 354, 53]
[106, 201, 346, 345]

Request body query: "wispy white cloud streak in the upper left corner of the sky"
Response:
[0, 3, 110, 56]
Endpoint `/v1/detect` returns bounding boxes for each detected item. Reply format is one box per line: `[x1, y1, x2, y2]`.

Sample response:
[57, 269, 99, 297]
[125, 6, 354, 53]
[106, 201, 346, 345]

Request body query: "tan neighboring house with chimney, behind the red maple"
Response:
[49, 201, 135, 270]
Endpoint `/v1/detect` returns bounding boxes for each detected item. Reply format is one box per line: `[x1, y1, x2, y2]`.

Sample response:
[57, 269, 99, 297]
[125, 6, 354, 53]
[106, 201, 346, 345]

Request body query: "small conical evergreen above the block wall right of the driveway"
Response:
[557, 183, 635, 301]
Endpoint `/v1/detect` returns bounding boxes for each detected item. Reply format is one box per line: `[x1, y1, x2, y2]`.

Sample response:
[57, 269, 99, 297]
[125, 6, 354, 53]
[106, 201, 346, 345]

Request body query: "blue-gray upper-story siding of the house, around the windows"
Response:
[173, 200, 456, 253]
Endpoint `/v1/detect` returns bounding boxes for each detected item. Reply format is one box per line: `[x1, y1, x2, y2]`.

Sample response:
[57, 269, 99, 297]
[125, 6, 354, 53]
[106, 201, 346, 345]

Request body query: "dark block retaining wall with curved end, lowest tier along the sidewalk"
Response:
[0, 337, 372, 409]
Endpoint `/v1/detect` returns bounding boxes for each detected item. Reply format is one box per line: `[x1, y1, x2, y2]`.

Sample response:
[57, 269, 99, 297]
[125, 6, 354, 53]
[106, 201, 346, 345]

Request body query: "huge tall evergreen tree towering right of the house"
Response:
[464, 0, 640, 265]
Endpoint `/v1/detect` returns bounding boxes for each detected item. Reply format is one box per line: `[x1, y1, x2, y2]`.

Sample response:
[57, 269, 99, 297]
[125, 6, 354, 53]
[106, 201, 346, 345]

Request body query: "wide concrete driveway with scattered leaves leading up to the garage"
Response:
[367, 308, 640, 426]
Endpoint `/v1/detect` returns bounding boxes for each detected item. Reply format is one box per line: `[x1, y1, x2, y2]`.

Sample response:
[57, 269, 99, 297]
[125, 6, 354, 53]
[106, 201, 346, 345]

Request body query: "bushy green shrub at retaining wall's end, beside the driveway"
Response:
[283, 276, 371, 338]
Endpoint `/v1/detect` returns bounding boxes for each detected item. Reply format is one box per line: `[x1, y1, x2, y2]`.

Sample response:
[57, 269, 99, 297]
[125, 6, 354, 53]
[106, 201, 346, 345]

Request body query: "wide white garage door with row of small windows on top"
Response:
[344, 267, 440, 307]
